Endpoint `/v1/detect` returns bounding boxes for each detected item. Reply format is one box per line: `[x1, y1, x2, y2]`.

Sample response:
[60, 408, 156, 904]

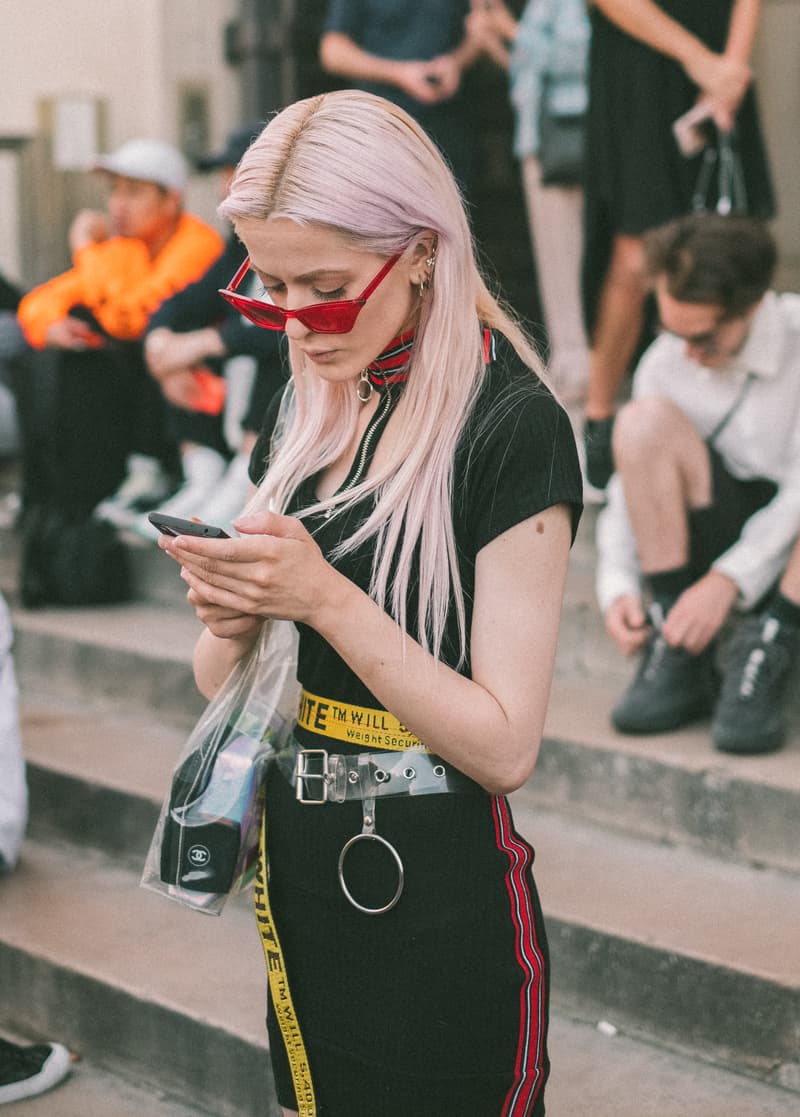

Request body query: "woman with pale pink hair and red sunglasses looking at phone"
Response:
[161, 90, 581, 1117]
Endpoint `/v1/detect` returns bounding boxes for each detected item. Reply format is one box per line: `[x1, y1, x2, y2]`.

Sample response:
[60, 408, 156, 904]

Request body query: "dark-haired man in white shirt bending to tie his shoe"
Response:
[597, 214, 800, 753]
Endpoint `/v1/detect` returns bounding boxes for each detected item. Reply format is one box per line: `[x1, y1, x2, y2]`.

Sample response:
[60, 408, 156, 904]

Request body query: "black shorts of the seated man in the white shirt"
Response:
[689, 446, 778, 580]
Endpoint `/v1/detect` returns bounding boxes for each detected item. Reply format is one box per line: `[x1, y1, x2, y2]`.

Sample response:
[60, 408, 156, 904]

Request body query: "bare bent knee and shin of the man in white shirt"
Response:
[613, 397, 710, 577]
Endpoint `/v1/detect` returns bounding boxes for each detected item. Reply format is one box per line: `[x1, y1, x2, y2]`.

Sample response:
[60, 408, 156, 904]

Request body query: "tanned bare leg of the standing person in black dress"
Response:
[585, 236, 646, 419]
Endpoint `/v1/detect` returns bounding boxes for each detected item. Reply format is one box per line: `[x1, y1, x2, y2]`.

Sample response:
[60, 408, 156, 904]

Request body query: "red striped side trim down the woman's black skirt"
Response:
[492, 795, 544, 1117]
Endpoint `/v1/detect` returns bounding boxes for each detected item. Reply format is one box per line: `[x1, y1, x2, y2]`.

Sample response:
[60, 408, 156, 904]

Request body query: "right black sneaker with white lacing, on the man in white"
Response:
[711, 614, 800, 753]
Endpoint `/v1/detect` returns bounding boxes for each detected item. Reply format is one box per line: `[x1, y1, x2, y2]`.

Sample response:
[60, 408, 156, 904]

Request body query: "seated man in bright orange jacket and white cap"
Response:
[17, 140, 223, 514]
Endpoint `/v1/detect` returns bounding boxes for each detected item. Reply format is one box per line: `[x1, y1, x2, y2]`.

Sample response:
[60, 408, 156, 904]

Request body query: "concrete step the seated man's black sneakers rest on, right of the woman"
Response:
[525, 677, 800, 873]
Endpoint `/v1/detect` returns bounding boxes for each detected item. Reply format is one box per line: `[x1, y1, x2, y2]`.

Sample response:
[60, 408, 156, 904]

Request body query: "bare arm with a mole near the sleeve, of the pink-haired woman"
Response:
[160, 506, 570, 793]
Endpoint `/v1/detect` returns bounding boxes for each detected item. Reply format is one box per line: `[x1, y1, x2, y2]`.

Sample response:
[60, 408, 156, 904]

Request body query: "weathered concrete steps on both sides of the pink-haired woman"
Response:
[0, 511, 800, 1117]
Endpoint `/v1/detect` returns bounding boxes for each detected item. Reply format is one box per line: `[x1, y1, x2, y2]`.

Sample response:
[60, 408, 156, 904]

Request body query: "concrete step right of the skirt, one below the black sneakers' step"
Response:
[522, 813, 800, 1085]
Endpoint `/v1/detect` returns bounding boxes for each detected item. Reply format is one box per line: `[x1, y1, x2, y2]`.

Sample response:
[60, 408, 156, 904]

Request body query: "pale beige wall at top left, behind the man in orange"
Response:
[0, 0, 239, 284]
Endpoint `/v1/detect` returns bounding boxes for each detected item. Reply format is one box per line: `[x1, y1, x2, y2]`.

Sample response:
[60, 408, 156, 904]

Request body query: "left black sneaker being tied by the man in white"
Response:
[611, 631, 716, 733]
